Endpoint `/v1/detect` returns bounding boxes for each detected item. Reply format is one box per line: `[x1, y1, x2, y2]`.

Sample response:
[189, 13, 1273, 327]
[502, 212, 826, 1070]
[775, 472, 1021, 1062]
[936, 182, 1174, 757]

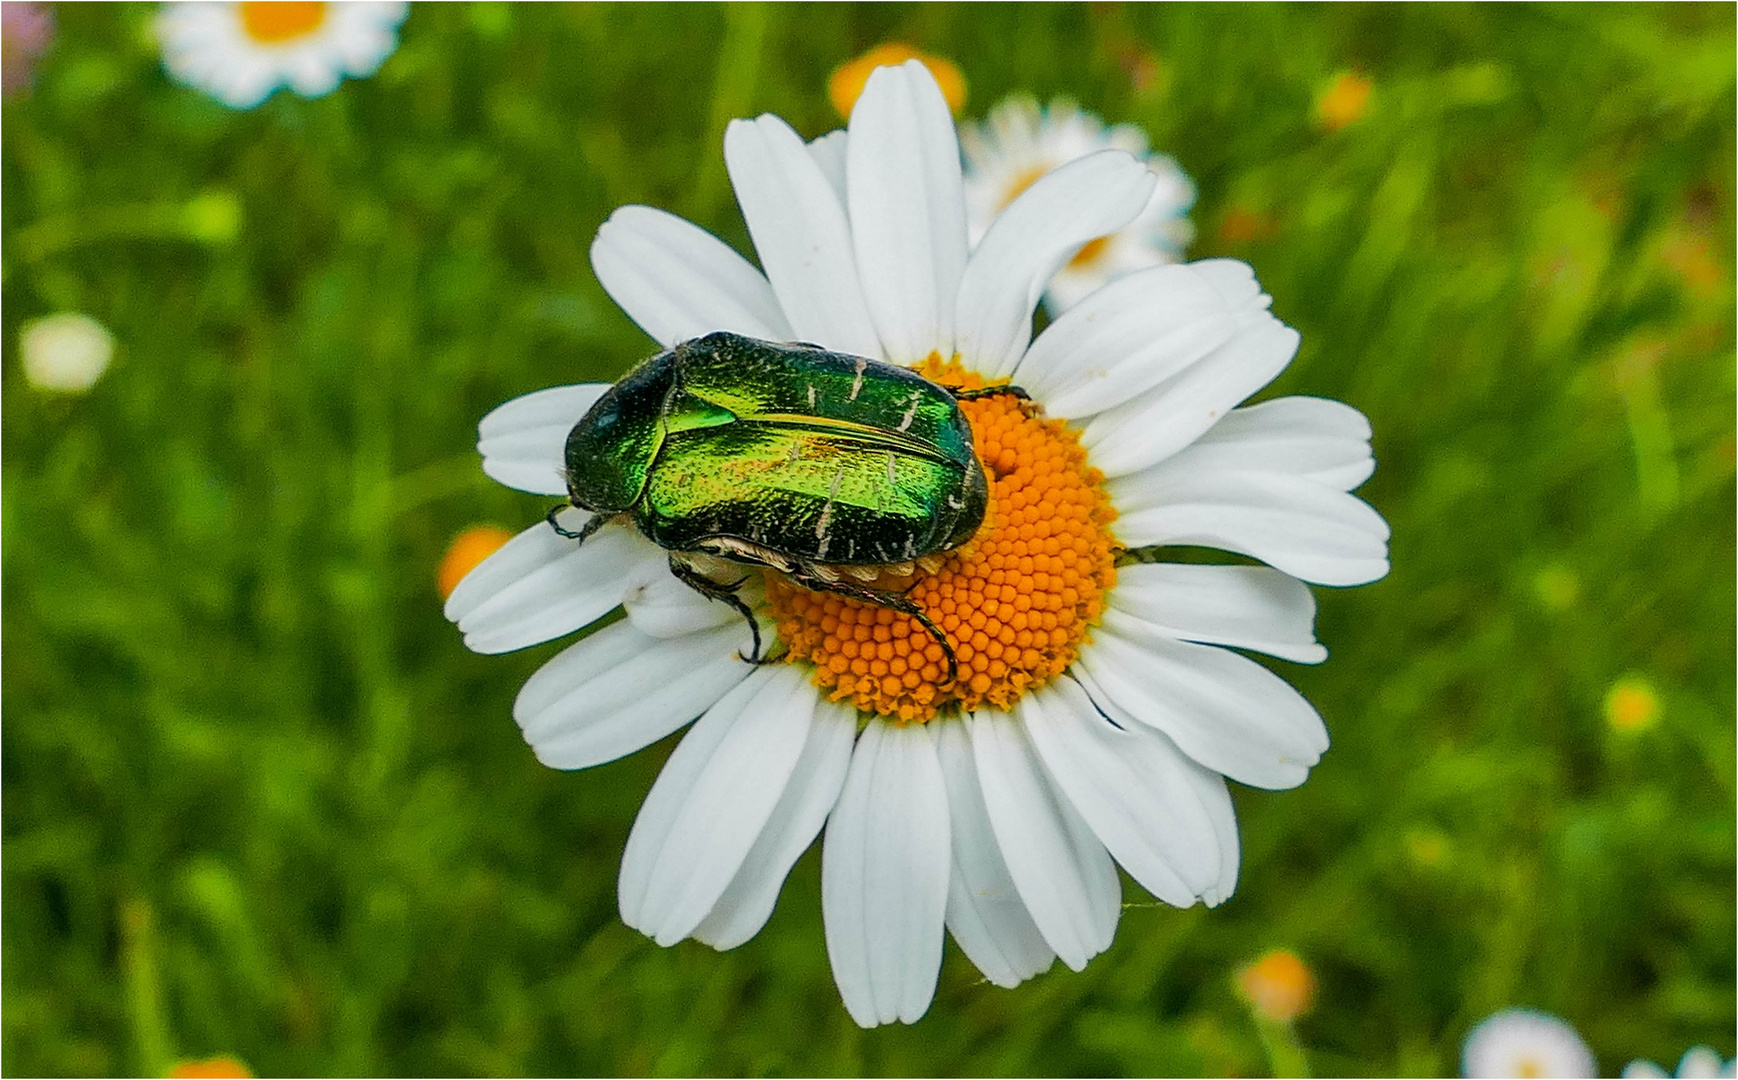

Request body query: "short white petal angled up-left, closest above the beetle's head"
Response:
[591, 207, 791, 346]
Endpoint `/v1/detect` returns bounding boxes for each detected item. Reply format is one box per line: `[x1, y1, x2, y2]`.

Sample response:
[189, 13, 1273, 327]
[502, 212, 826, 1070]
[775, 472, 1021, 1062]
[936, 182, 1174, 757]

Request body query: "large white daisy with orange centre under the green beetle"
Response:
[447, 61, 1389, 1026]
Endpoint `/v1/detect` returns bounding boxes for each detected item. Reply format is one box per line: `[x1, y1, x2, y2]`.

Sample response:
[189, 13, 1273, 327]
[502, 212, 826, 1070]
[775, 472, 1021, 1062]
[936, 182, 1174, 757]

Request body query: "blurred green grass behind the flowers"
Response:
[0, 3, 1735, 1075]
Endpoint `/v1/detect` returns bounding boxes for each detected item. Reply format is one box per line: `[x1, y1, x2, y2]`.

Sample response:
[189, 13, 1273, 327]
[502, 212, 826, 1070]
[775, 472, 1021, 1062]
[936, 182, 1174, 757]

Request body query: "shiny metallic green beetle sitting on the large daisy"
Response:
[549, 332, 1024, 673]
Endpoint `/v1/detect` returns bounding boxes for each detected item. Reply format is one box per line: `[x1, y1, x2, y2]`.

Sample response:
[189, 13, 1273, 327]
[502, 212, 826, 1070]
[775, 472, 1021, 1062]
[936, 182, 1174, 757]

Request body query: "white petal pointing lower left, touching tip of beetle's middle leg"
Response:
[513, 623, 754, 769]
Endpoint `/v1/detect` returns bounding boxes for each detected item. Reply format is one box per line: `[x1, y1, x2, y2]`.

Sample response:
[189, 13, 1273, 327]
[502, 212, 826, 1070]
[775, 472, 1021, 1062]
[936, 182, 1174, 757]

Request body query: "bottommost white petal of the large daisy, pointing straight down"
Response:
[820, 720, 951, 1028]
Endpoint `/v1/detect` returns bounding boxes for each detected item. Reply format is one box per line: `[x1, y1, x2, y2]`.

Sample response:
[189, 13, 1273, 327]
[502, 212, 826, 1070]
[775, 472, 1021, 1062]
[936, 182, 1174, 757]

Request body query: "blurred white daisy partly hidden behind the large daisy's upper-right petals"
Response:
[959, 96, 1194, 315]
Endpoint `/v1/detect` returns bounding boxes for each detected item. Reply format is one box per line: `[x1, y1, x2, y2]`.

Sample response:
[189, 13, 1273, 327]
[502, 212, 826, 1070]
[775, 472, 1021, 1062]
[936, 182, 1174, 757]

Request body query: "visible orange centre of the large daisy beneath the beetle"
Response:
[766, 355, 1121, 723]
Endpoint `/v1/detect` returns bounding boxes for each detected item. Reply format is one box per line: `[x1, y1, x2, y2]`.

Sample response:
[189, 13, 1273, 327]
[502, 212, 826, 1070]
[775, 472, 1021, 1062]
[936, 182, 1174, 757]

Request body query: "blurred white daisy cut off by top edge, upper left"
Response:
[158, 0, 410, 110]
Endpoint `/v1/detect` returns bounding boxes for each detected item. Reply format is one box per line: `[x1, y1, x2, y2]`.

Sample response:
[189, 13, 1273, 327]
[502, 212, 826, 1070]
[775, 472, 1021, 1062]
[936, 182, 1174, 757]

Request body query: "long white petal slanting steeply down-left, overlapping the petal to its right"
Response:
[617, 664, 817, 946]
